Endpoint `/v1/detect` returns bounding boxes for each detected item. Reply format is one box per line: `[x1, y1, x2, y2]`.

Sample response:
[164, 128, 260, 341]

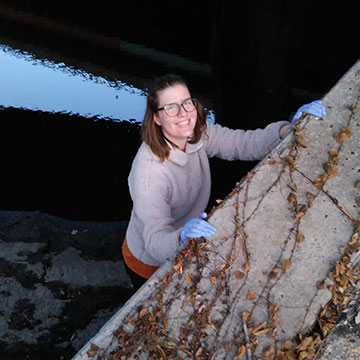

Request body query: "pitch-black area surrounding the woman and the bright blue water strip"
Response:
[0, 0, 359, 221]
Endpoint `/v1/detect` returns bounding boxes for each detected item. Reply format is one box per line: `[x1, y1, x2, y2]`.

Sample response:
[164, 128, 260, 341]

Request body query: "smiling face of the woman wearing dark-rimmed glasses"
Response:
[154, 84, 197, 149]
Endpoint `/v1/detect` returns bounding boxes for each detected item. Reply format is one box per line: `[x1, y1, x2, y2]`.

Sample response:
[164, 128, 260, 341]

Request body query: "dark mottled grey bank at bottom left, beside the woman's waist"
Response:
[0, 211, 132, 360]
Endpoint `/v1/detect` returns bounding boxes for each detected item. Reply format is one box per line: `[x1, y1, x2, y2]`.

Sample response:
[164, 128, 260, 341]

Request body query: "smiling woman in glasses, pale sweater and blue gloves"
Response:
[122, 74, 325, 288]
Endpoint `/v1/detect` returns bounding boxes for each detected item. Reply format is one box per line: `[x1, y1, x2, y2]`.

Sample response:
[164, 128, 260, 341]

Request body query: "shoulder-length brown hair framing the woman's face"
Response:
[141, 74, 206, 161]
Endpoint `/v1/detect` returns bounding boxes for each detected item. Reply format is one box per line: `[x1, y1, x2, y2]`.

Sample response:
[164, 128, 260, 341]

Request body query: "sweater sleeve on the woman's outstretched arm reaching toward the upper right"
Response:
[206, 121, 289, 160]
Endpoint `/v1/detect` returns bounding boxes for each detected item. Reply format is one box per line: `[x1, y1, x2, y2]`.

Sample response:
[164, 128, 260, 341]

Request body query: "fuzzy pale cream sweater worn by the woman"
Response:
[126, 121, 289, 266]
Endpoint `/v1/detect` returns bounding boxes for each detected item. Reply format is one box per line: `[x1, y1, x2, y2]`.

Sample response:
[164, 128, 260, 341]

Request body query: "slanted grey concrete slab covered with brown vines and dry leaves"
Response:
[74, 61, 360, 360]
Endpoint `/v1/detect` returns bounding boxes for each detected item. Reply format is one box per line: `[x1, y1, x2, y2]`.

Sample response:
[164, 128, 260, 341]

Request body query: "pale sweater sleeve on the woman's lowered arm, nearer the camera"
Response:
[129, 158, 181, 263]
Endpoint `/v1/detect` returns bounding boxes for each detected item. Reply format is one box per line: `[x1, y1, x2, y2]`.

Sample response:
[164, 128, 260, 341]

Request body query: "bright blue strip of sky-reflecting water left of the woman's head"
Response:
[0, 45, 146, 123]
